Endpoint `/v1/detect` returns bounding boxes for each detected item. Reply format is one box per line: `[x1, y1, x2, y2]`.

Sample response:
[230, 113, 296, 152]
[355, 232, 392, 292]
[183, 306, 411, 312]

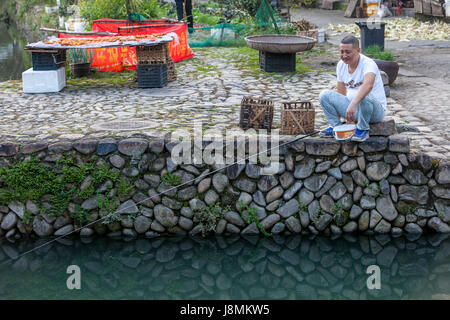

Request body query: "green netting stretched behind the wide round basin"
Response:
[188, 0, 283, 48]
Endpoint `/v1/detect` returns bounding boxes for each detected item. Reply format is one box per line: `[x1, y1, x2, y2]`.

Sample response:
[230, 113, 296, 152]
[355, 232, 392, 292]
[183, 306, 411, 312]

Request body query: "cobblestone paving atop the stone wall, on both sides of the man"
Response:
[0, 48, 450, 158]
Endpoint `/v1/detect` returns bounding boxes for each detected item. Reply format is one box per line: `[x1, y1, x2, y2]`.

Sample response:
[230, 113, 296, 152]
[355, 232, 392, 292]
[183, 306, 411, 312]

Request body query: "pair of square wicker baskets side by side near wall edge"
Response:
[239, 97, 316, 135]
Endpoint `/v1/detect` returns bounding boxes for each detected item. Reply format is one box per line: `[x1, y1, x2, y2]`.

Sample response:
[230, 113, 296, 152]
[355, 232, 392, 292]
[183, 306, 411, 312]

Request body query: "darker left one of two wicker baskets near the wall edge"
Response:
[239, 97, 273, 130]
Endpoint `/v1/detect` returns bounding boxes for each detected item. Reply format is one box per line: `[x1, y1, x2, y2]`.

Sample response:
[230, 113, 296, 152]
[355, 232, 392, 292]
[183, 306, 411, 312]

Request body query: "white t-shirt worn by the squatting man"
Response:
[336, 54, 387, 110]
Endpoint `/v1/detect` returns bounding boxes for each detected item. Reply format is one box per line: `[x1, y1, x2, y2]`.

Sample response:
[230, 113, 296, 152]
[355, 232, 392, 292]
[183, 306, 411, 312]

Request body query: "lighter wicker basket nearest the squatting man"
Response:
[281, 101, 316, 135]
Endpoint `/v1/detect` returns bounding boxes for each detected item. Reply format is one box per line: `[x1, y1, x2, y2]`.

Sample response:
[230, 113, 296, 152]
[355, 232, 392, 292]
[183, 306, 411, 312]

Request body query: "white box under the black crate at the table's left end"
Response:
[22, 67, 66, 93]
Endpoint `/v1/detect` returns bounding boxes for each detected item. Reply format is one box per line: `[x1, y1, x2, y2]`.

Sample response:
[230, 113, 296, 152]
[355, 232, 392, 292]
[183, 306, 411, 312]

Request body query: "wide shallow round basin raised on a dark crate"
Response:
[245, 34, 316, 53]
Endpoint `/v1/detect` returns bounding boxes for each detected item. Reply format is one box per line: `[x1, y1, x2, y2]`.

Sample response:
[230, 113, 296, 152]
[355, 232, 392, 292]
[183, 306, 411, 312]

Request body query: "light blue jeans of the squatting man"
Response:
[319, 90, 384, 130]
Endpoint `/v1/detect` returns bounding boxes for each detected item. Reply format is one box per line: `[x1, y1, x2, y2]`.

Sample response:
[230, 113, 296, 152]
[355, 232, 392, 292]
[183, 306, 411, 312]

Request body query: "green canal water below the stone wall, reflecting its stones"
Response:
[0, 234, 450, 300]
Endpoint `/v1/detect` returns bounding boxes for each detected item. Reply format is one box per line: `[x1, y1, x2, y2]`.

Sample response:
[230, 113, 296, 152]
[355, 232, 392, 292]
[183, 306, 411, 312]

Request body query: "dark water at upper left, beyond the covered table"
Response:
[0, 22, 32, 82]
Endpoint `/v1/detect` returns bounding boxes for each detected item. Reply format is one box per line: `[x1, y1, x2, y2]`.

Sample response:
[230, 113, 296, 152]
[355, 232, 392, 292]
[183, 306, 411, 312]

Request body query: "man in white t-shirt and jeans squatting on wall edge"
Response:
[319, 36, 387, 141]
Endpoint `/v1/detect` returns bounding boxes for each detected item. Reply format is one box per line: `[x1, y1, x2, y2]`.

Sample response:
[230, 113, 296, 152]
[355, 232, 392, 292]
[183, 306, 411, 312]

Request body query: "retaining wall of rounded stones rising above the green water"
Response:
[0, 121, 450, 238]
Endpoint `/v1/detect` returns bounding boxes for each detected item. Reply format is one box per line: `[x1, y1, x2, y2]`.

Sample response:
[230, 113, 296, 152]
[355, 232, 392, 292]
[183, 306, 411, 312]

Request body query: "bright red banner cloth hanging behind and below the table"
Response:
[58, 19, 194, 71]
